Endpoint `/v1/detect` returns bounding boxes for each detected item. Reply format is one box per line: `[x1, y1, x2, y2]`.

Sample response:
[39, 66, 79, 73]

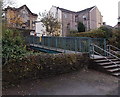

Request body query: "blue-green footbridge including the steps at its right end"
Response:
[26, 36, 120, 77]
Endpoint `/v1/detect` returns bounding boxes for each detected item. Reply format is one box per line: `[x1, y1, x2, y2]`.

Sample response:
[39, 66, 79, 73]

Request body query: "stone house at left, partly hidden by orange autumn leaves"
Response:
[4, 5, 38, 32]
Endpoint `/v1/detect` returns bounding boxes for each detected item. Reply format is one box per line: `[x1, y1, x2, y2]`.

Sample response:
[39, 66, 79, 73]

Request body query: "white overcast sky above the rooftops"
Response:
[15, 0, 120, 26]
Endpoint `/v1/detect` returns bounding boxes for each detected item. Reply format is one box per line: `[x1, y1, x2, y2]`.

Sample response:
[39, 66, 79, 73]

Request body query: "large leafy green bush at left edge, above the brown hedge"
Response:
[2, 28, 27, 65]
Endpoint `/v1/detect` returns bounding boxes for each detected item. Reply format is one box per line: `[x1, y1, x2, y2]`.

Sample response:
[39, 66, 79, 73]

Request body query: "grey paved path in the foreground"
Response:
[3, 70, 118, 95]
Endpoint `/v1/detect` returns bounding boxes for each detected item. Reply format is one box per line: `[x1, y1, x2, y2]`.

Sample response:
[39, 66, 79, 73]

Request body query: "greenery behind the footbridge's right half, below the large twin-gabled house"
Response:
[68, 26, 120, 48]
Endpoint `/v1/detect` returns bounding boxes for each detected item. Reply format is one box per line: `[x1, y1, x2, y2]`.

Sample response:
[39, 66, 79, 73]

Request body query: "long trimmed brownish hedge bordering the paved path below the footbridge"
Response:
[2, 54, 89, 87]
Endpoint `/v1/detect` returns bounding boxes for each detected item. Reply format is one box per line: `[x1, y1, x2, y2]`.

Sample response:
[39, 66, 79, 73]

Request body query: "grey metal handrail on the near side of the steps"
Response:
[91, 44, 120, 66]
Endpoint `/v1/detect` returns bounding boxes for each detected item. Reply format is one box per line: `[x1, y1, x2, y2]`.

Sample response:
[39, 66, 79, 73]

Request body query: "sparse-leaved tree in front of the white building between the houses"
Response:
[40, 12, 61, 36]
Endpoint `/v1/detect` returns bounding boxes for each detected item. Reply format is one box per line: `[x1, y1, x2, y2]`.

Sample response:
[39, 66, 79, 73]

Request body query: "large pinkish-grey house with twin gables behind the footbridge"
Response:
[50, 6, 103, 36]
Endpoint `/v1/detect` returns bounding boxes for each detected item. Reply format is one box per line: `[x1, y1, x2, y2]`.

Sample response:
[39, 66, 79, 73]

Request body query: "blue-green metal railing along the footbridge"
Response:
[27, 36, 106, 54]
